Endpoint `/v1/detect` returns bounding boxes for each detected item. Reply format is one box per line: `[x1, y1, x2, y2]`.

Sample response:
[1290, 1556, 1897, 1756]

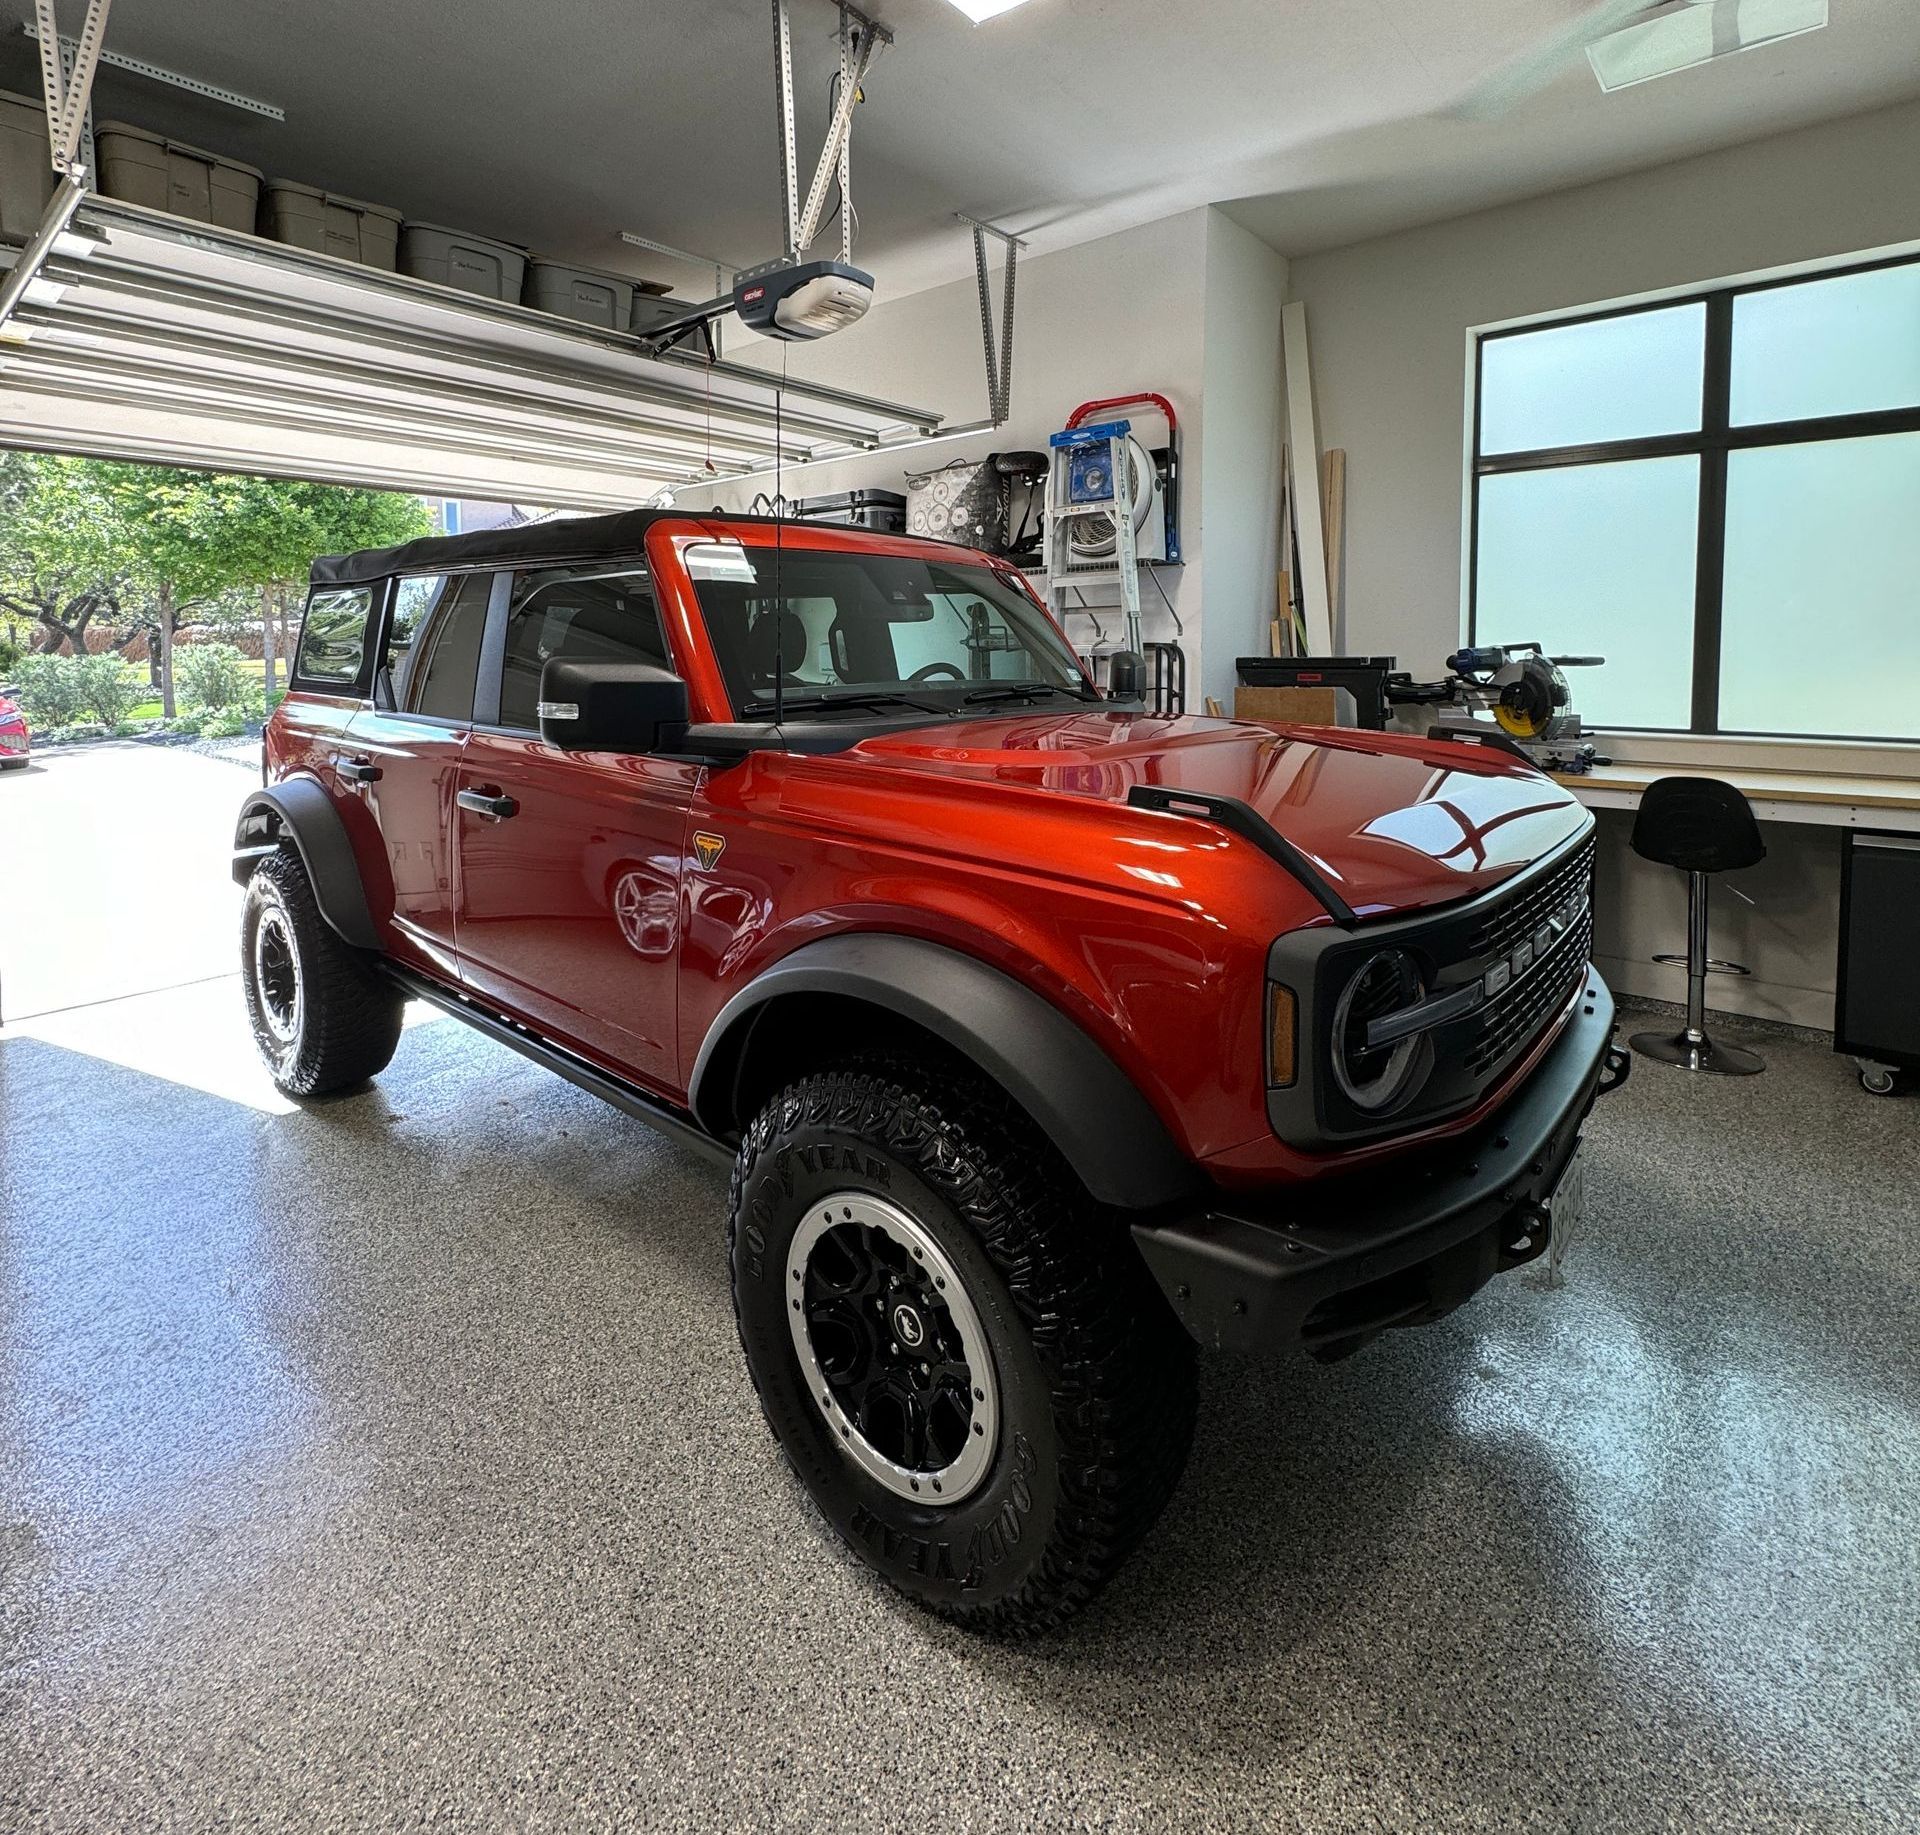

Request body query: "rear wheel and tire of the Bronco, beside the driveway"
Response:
[240, 854, 405, 1096]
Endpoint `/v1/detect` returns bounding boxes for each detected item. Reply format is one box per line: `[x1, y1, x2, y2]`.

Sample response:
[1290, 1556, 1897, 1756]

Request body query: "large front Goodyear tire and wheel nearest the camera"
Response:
[728, 1063, 1194, 1632]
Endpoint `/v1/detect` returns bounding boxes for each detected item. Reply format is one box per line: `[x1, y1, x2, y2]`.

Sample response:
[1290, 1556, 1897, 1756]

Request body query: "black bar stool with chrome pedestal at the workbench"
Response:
[1628, 777, 1766, 1077]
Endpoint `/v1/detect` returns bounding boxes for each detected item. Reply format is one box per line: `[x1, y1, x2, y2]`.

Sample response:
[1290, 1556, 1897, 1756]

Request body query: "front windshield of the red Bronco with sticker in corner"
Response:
[684, 541, 1092, 720]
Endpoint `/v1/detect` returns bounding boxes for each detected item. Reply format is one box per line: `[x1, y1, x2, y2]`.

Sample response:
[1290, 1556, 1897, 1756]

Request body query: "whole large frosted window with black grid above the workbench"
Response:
[1467, 255, 1920, 741]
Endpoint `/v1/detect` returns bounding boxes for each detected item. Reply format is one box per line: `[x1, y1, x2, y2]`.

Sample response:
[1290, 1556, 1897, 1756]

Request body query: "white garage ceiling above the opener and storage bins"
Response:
[0, 0, 1920, 296]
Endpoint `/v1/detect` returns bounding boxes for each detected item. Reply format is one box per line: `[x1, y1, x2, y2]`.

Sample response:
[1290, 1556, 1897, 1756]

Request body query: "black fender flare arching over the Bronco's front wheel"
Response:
[687, 933, 1200, 1209]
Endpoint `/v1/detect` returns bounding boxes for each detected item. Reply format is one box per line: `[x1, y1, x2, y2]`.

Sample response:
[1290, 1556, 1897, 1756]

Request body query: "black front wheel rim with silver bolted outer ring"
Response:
[785, 1192, 1000, 1505]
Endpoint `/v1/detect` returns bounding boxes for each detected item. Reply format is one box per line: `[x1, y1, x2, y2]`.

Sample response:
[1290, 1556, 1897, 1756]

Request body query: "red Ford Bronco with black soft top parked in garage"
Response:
[234, 511, 1624, 1630]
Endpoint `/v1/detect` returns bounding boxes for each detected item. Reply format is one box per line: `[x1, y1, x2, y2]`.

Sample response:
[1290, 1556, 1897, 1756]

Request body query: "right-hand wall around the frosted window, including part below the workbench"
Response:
[1292, 104, 1920, 1027]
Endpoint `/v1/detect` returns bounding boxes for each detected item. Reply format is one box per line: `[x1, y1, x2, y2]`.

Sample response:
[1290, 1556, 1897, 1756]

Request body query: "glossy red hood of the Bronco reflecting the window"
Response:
[852, 710, 1592, 918]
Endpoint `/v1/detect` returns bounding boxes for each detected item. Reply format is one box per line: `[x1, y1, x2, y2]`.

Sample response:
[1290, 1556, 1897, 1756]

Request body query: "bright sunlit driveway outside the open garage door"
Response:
[0, 745, 259, 1023]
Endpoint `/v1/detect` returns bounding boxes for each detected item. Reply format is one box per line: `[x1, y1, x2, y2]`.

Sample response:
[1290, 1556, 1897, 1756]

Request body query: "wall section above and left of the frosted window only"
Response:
[1292, 104, 1920, 672]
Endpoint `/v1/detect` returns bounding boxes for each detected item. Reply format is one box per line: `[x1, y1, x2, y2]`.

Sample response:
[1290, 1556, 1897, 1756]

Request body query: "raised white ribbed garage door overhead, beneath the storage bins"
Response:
[0, 194, 941, 509]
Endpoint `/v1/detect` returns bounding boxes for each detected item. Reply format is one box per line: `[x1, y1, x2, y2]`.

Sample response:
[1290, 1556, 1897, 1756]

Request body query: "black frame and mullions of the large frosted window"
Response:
[1465, 248, 1920, 745]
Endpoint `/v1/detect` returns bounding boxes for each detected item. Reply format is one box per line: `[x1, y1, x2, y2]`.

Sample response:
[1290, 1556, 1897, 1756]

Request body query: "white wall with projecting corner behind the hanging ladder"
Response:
[695, 209, 1286, 710]
